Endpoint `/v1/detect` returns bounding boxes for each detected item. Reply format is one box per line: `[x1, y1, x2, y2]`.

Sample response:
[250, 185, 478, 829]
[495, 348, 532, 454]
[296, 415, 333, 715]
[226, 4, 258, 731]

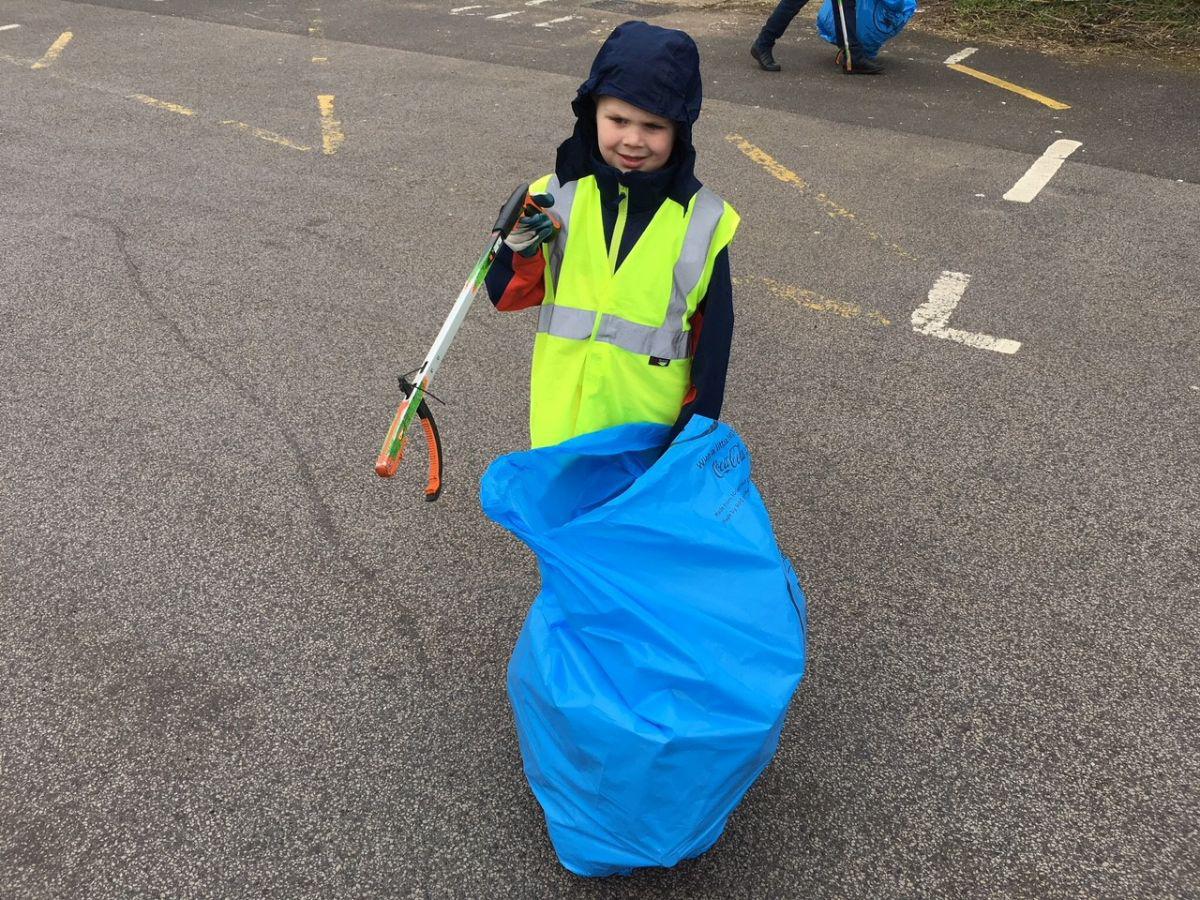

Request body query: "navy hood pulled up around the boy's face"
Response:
[556, 22, 703, 211]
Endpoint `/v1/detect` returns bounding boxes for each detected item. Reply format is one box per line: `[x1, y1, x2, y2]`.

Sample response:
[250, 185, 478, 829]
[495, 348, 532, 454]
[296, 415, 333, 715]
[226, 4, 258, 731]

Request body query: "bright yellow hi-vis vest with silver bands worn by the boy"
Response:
[529, 175, 740, 446]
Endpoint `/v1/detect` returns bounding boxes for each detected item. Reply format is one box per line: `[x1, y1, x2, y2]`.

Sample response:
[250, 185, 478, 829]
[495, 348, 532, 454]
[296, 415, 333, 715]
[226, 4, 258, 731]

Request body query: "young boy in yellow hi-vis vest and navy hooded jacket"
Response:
[487, 22, 739, 446]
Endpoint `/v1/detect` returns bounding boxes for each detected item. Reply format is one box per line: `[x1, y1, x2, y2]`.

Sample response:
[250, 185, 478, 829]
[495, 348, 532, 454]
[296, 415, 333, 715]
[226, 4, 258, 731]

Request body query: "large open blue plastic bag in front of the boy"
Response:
[481, 416, 806, 876]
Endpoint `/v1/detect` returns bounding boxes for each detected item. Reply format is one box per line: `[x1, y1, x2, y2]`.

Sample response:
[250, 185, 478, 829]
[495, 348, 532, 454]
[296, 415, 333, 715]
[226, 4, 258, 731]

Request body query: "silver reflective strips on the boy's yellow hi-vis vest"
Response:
[538, 184, 725, 359]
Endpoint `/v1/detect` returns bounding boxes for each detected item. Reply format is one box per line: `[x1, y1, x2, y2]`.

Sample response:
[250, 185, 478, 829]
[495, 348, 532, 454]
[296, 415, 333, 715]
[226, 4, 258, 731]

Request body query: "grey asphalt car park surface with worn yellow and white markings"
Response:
[0, 0, 1200, 898]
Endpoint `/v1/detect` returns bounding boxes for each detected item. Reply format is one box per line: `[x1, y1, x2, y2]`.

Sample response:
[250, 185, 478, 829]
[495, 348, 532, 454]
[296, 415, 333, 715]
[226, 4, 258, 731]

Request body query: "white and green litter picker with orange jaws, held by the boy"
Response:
[376, 185, 553, 500]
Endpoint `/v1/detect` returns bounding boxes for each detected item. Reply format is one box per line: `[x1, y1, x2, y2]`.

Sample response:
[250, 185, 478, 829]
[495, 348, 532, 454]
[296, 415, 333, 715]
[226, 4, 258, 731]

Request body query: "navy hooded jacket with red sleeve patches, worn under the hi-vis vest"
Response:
[487, 22, 733, 438]
